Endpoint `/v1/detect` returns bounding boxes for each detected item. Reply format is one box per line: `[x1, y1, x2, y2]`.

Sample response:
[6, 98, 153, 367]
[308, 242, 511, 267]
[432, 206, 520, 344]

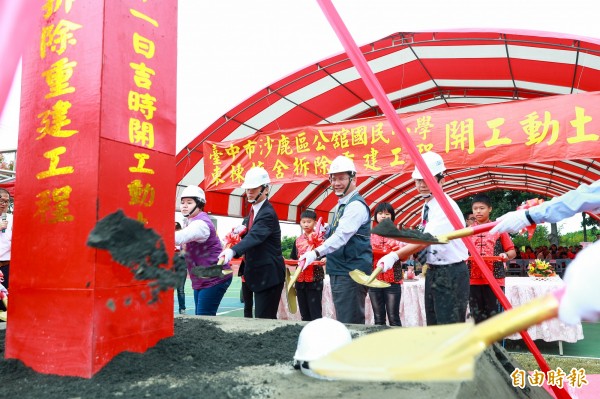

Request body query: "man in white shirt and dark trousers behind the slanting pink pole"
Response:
[377, 152, 469, 326]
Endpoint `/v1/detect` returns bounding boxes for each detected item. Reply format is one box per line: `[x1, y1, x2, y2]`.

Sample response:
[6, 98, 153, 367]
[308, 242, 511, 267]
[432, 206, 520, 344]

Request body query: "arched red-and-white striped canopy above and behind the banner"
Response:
[177, 31, 600, 226]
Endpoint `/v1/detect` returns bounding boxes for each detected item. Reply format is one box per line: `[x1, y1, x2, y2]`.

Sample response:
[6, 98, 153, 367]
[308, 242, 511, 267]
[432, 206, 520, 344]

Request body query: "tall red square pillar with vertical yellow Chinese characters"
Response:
[6, 0, 177, 377]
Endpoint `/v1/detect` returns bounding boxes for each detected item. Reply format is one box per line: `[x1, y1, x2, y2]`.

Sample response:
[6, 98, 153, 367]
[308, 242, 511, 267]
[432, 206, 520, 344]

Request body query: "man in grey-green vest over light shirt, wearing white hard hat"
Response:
[299, 155, 373, 324]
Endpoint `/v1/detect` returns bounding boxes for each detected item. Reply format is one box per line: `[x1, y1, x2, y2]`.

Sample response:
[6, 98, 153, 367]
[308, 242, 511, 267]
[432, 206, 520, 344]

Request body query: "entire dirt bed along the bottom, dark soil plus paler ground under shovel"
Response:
[0, 317, 550, 399]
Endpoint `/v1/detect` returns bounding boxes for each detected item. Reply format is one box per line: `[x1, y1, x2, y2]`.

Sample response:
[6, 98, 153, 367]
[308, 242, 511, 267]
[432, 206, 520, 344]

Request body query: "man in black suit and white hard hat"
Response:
[219, 167, 285, 319]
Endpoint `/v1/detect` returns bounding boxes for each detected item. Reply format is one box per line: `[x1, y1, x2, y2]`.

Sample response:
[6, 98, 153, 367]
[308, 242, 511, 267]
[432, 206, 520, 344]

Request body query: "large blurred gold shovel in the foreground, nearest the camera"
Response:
[309, 288, 564, 381]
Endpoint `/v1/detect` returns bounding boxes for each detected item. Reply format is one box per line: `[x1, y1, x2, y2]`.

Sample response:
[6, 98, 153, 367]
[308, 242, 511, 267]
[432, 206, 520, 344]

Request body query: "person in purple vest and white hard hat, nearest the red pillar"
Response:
[175, 186, 233, 316]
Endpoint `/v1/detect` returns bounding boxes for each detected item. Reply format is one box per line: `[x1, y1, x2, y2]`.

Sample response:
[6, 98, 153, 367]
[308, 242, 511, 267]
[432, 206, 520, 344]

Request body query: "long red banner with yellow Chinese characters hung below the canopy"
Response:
[203, 92, 600, 190]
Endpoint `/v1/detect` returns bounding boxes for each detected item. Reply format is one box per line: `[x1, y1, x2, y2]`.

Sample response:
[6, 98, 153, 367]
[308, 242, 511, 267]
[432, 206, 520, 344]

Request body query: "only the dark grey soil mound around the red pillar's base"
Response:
[0, 318, 302, 398]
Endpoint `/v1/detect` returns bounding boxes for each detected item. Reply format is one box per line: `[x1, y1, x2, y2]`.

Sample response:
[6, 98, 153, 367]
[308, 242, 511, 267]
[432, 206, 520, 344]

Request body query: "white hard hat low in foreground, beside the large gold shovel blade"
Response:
[294, 317, 352, 372]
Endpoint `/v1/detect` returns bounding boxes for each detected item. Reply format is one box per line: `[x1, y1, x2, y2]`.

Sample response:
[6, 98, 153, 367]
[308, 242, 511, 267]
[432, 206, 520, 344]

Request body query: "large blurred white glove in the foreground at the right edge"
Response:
[558, 242, 600, 324]
